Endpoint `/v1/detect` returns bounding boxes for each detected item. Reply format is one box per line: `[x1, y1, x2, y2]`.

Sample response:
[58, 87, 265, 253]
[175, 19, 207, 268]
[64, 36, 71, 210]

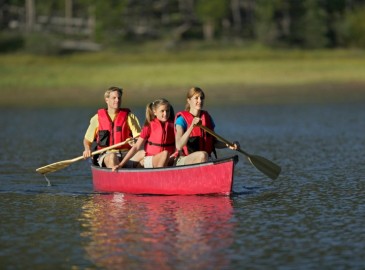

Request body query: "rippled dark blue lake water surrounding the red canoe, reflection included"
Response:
[0, 104, 365, 269]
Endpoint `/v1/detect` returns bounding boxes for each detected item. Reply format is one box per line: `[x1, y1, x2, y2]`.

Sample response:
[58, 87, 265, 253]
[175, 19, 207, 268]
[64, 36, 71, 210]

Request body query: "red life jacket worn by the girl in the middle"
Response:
[144, 118, 175, 156]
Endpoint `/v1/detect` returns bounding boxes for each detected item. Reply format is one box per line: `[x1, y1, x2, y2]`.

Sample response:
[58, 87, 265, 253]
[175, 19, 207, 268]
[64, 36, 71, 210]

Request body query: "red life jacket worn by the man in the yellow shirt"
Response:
[96, 109, 132, 150]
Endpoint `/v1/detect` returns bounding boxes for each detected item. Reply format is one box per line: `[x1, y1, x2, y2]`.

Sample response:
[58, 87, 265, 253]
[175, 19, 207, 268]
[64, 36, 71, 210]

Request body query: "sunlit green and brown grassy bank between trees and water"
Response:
[0, 48, 365, 107]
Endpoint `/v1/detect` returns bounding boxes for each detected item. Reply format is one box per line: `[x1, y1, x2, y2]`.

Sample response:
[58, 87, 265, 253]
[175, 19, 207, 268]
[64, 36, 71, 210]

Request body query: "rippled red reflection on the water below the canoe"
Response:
[80, 193, 235, 269]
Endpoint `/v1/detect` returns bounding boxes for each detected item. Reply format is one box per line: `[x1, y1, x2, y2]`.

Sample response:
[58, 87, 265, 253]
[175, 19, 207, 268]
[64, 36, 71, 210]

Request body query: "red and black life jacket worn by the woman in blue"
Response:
[175, 110, 215, 156]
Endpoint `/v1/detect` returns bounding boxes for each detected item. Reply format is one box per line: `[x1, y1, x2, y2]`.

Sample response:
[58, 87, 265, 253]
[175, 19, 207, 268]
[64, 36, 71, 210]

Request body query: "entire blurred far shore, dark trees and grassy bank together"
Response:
[0, 0, 365, 106]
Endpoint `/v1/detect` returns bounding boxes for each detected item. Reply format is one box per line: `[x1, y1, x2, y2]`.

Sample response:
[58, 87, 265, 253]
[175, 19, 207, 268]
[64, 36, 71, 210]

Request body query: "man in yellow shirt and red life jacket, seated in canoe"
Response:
[83, 86, 144, 168]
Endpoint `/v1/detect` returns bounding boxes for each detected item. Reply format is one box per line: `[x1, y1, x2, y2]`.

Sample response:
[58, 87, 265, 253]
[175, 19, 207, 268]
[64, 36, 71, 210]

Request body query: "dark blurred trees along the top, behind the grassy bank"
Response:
[0, 0, 365, 53]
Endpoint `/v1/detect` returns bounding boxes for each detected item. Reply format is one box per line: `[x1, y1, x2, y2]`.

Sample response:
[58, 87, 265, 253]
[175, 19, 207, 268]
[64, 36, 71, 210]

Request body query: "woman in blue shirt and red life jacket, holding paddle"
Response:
[175, 87, 239, 165]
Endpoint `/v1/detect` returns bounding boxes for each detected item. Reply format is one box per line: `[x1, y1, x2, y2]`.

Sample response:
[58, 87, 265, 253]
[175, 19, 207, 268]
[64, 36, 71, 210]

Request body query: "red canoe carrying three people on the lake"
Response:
[91, 156, 238, 195]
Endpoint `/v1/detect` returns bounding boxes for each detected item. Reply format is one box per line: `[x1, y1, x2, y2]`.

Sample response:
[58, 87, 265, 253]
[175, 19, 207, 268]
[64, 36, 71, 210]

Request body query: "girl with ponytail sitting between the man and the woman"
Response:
[112, 98, 175, 171]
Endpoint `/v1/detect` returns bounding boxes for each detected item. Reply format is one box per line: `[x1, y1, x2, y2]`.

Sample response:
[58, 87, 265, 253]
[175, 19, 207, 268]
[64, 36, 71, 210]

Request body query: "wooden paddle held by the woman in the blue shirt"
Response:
[197, 124, 281, 180]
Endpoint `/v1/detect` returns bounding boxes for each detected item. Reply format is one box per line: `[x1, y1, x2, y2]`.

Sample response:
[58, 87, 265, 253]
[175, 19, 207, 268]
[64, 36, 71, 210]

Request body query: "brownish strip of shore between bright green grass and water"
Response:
[0, 83, 365, 108]
